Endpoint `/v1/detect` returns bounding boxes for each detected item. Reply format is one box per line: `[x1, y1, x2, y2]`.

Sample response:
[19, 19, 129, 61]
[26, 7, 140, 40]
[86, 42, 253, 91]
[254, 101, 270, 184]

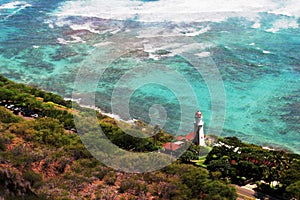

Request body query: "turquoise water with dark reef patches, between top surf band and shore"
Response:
[0, 0, 300, 153]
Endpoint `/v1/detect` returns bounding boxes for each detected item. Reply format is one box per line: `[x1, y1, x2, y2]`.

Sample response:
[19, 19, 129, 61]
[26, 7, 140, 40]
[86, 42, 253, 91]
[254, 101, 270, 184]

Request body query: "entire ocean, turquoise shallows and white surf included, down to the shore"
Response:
[0, 0, 300, 153]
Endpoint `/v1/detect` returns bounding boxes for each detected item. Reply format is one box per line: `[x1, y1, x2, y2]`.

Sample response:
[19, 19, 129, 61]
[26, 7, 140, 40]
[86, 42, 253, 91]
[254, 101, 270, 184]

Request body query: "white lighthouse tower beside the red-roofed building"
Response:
[193, 111, 206, 146]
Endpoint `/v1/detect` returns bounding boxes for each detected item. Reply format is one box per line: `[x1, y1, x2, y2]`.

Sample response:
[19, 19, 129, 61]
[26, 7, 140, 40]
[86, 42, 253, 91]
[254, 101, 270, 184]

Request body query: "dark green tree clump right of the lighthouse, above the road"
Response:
[205, 137, 300, 199]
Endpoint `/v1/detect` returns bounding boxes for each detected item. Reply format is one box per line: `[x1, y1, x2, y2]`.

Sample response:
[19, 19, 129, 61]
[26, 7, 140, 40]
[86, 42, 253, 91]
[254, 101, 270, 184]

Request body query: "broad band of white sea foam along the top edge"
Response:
[56, 0, 300, 23]
